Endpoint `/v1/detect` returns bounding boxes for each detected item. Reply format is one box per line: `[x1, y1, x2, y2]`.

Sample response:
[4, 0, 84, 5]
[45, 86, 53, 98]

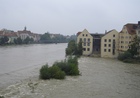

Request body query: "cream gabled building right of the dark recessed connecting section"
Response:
[101, 30, 119, 58]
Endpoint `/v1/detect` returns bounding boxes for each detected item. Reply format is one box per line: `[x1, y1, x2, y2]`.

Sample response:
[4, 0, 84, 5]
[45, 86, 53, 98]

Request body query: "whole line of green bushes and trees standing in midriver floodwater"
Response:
[39, 40, 82, 79]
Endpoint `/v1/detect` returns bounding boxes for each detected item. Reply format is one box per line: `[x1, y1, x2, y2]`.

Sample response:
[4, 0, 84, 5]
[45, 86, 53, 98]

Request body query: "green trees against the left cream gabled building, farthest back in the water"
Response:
[65, 40, 83, 56]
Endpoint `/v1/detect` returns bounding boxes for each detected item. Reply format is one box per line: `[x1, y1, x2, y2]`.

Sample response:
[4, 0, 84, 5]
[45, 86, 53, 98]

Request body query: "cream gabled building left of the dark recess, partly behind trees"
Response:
[77, 29, 93, 55]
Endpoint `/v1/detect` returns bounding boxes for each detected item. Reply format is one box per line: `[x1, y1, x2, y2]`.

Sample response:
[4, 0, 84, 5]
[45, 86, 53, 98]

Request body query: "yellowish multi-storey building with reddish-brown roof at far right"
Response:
[119, 24, 137, 53]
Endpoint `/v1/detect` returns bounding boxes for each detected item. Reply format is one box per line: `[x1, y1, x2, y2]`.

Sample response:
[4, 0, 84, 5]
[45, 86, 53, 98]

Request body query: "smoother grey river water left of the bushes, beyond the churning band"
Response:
[0, 44, 67, 87]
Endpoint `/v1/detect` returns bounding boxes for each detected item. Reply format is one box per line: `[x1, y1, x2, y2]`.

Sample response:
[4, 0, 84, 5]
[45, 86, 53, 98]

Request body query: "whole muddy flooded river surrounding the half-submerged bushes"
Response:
[0, 44, 140, 98]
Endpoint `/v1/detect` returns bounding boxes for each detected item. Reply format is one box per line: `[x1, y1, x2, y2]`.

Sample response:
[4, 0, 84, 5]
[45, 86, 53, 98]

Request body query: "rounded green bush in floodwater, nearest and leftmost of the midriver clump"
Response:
[40, 64, 65, 79]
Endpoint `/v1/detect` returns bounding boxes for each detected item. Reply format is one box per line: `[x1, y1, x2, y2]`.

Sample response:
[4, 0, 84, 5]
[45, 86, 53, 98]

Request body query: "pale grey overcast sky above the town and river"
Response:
[0, 0, 140, 35]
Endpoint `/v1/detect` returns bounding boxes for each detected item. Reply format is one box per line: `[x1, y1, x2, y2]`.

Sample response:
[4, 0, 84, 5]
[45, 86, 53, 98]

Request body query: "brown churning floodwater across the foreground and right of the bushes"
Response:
[0, 44, 140, 98]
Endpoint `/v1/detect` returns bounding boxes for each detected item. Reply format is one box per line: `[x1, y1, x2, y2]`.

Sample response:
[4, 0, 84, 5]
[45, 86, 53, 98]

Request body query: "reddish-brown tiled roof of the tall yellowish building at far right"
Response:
[125, 23, 138, 35]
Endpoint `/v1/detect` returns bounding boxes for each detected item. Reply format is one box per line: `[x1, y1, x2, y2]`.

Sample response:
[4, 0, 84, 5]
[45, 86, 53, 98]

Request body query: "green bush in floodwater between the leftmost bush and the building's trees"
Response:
[53, 56, 79, 75]
